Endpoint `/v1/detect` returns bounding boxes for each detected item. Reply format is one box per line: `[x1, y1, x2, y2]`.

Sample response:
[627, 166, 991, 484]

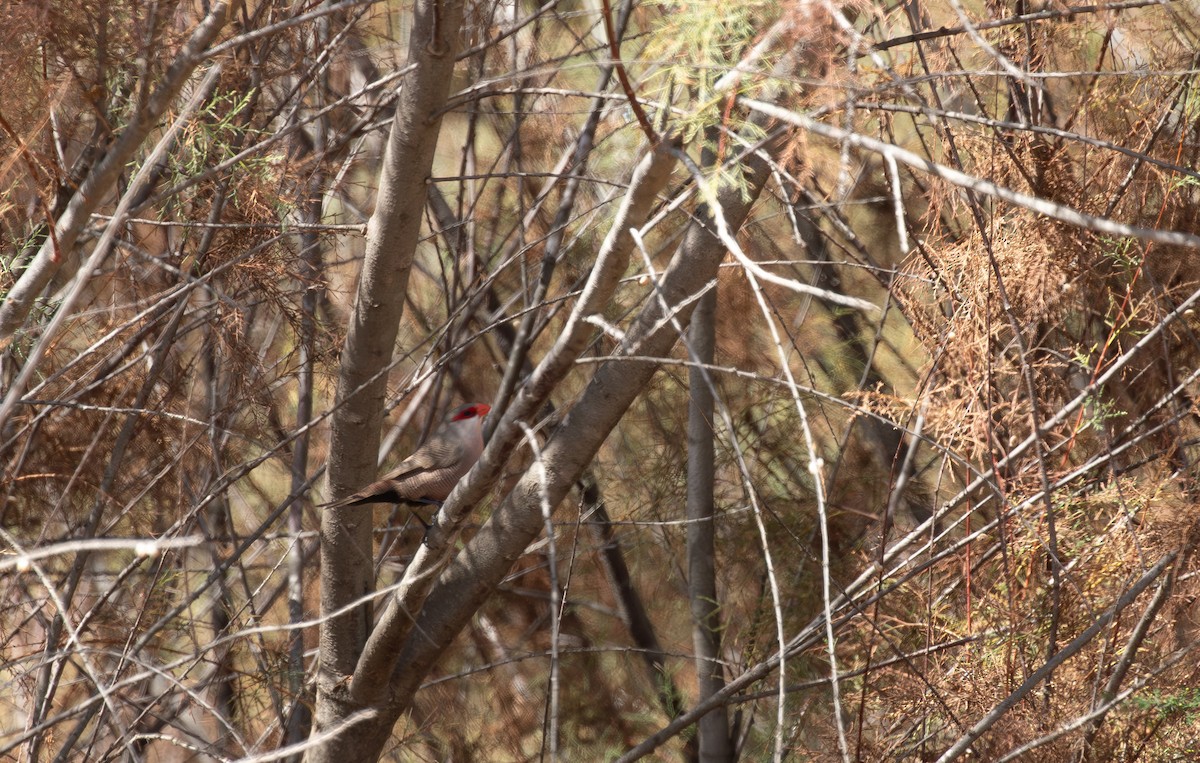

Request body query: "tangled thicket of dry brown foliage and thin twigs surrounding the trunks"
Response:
[0, 0, 1200, 762]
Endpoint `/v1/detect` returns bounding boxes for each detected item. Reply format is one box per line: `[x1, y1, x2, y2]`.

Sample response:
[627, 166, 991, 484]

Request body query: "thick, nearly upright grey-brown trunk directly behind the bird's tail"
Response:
[306, 0, 463, 762]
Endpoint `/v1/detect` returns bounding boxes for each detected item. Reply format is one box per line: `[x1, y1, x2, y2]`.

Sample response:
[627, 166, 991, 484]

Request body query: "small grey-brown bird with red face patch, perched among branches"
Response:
[320, 403, 492, 509]
